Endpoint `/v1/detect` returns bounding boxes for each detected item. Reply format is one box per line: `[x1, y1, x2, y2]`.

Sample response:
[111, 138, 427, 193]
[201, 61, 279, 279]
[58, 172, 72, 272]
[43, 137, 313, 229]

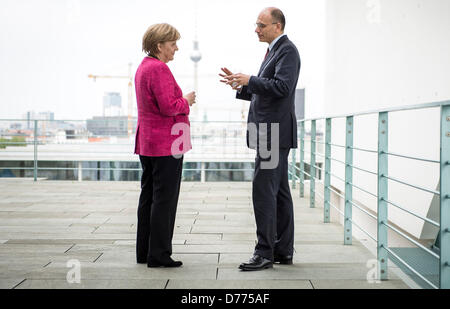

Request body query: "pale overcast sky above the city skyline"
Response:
[0, 0, 325, 120]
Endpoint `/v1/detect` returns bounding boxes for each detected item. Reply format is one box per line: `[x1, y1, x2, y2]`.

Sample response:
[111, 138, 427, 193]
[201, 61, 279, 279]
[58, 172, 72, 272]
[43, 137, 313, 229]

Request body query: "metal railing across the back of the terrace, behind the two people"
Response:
[0, 119, 254, 182]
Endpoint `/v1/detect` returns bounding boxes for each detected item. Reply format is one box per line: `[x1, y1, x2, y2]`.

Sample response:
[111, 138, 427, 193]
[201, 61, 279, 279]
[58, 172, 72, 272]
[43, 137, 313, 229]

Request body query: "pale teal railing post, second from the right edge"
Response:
[377, 112, 389, 280]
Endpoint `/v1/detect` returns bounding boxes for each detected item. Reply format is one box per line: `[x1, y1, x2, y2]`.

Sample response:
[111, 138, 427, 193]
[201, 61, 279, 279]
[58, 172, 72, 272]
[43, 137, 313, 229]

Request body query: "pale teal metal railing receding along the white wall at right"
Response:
[290, 101, 450, 289]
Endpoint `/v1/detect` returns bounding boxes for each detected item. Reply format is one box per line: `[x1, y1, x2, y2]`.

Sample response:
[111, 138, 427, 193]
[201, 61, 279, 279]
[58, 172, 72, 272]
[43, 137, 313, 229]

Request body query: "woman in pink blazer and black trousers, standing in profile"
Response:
[134, 24, 195, 267]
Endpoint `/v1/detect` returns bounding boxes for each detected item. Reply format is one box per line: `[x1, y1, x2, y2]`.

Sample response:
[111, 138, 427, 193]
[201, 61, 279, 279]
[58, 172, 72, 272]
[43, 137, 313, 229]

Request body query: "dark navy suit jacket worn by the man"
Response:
[236, 36, 301, 150]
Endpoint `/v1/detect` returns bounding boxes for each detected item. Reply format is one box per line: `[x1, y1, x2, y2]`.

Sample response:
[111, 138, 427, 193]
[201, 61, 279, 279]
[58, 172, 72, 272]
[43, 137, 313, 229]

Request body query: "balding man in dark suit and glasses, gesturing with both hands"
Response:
[219, 8, 300, 270]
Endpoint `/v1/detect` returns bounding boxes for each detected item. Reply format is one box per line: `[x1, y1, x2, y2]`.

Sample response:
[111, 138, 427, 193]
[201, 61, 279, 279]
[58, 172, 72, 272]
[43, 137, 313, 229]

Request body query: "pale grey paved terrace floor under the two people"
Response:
[0, 179, 408, 289]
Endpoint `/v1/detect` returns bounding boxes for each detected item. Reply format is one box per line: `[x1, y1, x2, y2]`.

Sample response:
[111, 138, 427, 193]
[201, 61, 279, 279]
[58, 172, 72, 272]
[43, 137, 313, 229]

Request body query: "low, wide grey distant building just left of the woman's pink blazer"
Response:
[86, 116, 137, 136]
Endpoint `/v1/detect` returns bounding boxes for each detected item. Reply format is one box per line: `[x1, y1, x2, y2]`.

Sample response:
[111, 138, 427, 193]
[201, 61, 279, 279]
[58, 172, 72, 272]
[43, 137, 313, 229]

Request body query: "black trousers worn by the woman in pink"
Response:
[136, 156, 183, 263]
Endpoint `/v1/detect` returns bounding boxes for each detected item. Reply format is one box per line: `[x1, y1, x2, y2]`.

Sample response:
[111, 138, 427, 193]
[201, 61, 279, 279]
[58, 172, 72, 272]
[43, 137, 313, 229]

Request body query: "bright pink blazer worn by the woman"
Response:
[134, 57, 192, 157]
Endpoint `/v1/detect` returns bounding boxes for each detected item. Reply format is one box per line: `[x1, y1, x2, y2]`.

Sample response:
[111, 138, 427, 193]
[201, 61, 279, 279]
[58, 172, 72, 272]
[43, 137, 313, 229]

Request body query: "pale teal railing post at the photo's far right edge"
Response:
[439, 105, 450, 289]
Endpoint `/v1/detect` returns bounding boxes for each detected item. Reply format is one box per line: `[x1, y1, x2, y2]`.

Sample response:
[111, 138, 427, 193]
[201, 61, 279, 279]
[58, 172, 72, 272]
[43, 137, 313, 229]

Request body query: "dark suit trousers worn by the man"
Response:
[252, 149, 294, 261]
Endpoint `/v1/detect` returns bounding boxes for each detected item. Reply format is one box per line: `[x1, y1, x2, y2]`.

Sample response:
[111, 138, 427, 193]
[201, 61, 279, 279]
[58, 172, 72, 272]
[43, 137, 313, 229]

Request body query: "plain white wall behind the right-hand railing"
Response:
[325, 0, 450, 239]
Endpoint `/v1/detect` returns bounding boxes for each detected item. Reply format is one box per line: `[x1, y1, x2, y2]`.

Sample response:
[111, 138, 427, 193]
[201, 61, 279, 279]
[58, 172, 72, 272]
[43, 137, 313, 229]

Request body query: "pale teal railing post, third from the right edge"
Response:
[344, 116, 353, 245]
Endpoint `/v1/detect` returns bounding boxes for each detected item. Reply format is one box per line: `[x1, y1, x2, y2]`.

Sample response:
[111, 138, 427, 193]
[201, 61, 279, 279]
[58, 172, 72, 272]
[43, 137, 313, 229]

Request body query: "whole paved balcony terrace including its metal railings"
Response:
[0, 101, 450, 289]
